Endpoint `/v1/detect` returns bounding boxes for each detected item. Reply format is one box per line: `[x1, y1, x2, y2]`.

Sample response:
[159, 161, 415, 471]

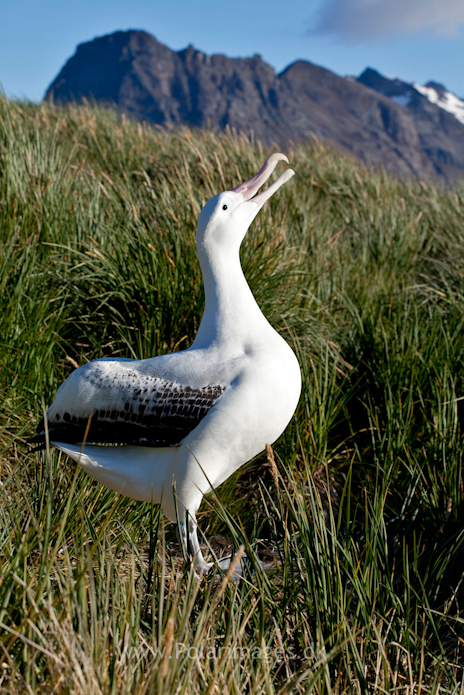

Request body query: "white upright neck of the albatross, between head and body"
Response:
[192, 249, 272, 349]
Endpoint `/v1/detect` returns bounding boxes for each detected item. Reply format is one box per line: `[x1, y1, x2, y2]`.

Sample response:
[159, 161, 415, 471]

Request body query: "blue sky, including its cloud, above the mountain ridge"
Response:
[0, 0, 464, 101]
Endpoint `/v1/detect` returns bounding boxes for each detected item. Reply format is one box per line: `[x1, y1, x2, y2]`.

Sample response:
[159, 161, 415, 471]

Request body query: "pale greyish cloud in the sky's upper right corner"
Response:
[309, 0, 464, 43]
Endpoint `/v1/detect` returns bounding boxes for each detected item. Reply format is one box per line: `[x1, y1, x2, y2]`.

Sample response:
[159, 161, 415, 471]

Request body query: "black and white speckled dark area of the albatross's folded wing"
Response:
[29, 368, 226, 450]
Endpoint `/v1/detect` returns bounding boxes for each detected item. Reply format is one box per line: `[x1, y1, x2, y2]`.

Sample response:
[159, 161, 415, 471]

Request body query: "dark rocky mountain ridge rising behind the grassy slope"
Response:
[45, 31, 464, 180]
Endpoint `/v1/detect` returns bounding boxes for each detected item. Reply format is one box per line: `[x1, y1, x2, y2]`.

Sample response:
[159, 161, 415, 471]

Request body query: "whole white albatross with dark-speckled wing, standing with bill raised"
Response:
[30, 153, 301, 574]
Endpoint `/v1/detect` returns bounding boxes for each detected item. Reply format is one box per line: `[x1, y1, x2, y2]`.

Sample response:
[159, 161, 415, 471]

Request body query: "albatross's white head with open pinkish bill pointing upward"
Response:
[197, 152, 295, 251]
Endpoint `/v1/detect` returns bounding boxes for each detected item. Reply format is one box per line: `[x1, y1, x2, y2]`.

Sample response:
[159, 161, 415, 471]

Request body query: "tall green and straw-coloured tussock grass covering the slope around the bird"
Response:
[0, 99, 464, 695]
